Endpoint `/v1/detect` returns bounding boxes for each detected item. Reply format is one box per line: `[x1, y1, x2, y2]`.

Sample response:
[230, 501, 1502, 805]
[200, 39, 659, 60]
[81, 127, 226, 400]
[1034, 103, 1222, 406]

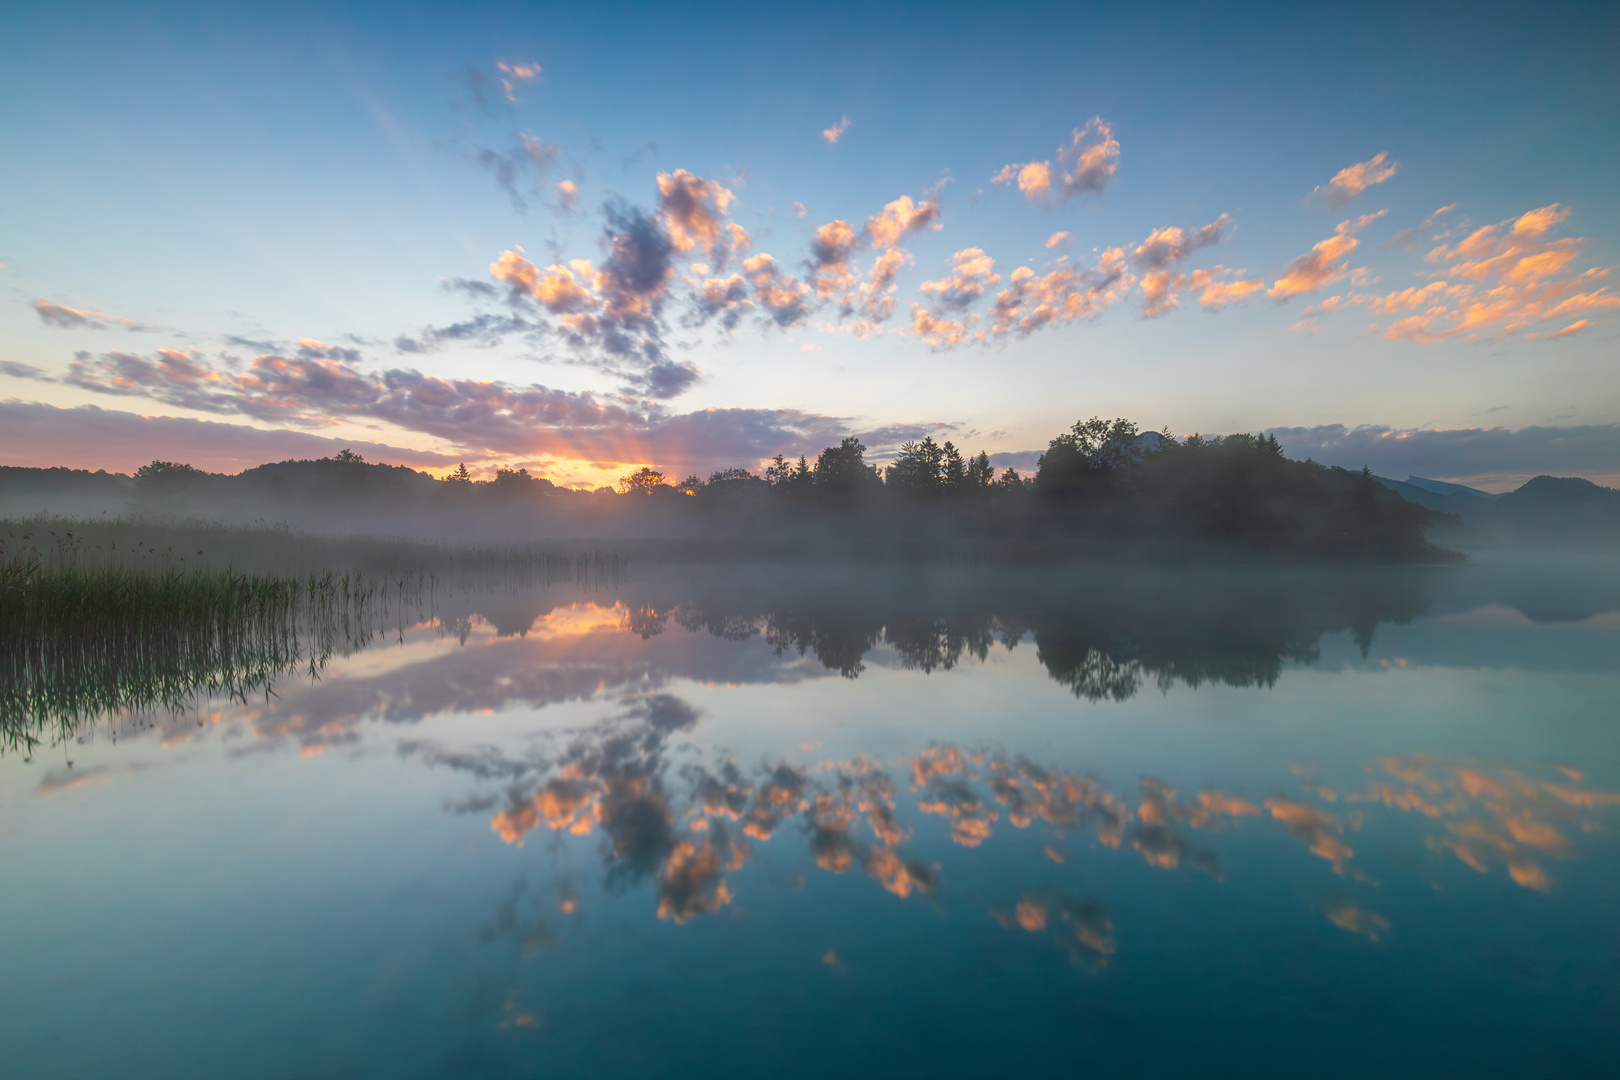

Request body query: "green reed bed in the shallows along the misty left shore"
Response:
[0, 518, 627, 755]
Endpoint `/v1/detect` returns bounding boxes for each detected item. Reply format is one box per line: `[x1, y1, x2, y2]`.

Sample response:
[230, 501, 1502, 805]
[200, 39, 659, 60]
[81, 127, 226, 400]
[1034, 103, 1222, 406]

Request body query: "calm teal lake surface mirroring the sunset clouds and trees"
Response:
[0, 560, 1620, 1077]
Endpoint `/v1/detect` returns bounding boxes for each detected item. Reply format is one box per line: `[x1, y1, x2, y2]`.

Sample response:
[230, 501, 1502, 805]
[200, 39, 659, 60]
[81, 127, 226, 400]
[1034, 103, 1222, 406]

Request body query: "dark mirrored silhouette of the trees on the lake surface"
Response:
[644, 576, 1427, 701]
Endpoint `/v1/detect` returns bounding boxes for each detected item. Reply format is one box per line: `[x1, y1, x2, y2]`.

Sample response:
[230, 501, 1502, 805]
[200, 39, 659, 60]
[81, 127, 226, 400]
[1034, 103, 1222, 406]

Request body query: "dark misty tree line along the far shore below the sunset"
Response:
[0, 418, 1455, 562]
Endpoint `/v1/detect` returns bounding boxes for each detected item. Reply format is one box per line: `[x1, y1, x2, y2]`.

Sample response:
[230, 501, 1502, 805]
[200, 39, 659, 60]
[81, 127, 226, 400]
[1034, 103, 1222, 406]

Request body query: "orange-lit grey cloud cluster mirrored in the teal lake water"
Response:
[403, 695, 1620, 968]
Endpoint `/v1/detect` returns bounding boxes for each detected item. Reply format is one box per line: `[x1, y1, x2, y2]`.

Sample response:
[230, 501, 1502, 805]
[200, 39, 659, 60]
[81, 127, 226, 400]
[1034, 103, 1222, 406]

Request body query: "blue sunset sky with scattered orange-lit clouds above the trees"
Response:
[0, 3, 1620, 489]
